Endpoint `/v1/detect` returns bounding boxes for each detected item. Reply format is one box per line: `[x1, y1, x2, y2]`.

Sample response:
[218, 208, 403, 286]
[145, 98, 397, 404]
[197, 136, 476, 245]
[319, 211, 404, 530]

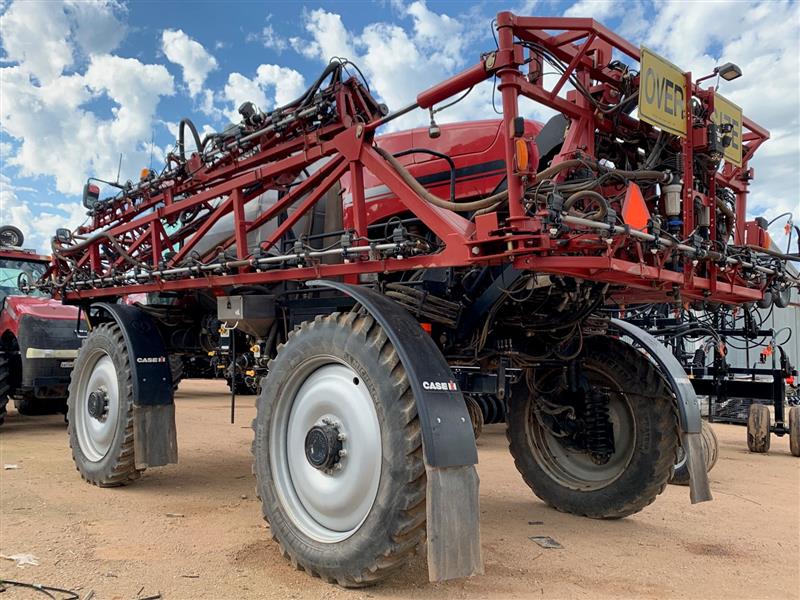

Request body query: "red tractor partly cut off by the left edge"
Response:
[0, 225, 81, 424]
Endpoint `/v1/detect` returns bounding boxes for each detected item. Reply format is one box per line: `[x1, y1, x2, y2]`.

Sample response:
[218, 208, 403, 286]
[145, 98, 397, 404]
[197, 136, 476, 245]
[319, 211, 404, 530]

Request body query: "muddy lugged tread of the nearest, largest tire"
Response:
[252, 312, 427, 588]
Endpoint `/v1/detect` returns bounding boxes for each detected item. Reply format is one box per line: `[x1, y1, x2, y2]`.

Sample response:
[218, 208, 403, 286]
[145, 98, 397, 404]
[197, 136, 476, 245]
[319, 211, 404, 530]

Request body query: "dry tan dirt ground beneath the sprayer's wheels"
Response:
[0, 381, 800, 600]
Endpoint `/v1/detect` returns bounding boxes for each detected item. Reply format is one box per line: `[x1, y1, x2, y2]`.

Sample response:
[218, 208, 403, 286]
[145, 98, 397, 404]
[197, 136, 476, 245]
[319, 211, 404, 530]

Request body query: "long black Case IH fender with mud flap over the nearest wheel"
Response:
[308, 281, 483, 581]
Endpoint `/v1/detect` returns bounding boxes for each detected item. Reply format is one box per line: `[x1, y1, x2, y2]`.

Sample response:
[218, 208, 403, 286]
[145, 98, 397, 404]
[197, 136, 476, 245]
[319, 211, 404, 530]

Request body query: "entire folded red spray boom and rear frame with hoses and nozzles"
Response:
[44, 12, 790, 310]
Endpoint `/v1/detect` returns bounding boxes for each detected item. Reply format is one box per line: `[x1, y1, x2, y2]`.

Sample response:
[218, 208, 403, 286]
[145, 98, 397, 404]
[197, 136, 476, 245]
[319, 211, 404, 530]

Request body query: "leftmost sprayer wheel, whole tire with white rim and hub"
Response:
[68, 323, 141, 487]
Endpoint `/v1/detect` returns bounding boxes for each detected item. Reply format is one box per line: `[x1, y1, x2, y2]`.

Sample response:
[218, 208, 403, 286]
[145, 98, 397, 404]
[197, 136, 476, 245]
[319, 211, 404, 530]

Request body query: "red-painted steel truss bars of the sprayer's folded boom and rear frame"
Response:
[53, 12, 769, 302]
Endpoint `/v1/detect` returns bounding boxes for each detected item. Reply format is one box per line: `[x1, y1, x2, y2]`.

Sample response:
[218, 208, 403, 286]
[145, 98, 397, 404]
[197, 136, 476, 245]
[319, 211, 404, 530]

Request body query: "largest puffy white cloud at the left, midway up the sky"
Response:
[0, 54, 173, 194]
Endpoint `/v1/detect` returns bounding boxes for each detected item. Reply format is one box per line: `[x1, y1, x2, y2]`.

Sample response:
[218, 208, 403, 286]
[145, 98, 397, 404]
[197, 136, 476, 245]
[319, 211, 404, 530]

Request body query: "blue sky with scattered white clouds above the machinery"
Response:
[0, 0, 800, 250]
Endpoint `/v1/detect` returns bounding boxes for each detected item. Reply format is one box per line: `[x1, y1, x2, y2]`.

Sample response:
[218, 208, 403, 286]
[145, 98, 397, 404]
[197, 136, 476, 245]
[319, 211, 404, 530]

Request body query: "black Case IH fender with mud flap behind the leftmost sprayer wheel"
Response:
[91, 303, 178, 469]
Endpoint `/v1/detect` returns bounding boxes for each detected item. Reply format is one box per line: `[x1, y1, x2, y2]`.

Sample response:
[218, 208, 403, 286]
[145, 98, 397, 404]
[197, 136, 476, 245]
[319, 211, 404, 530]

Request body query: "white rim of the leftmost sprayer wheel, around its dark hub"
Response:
[69, 350, 119, 462]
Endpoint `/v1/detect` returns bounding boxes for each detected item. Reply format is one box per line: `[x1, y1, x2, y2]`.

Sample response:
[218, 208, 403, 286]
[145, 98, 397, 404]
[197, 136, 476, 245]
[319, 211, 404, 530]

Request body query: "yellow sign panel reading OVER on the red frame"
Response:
[639, 47, 686, 137]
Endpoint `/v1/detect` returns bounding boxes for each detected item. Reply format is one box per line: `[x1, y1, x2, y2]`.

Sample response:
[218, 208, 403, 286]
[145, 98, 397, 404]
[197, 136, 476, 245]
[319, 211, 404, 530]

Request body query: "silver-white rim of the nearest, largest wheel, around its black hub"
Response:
[269, 357, 383, 543]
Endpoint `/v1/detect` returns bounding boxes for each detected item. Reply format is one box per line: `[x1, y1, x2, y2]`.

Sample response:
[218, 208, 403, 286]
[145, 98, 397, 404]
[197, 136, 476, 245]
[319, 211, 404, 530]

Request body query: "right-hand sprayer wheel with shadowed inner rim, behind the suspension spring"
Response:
[507, 338, 678, 519]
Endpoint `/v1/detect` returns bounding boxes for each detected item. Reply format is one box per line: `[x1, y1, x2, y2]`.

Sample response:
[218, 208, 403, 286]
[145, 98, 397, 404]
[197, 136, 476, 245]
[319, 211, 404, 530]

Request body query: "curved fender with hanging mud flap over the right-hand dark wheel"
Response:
[611, 319, 712, 504]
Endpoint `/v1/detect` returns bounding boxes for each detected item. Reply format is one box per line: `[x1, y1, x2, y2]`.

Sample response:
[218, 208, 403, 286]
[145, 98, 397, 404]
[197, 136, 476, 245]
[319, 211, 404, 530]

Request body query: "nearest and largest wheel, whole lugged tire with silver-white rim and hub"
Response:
[253, 313, 426, 587]
